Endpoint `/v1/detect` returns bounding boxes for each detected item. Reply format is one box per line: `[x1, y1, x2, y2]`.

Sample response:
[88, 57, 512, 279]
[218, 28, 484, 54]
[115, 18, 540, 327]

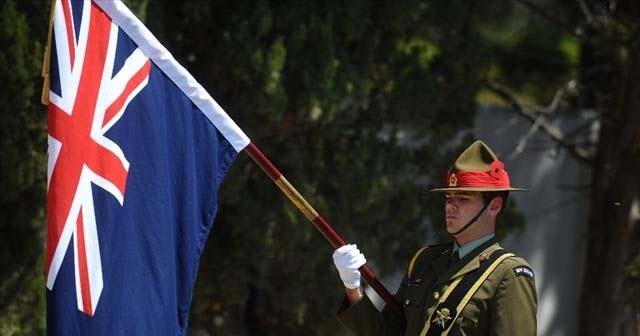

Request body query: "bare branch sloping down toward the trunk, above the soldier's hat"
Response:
[485, 80, 593, 165]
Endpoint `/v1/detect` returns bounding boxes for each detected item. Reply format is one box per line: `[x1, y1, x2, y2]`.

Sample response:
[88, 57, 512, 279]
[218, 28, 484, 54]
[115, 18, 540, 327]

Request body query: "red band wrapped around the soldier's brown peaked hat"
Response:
[445, 160, 509, 189]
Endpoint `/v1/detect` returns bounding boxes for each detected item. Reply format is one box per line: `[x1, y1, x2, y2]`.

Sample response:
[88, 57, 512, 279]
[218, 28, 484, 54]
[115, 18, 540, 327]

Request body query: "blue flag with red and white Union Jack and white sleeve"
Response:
[46, 0, 249, 335]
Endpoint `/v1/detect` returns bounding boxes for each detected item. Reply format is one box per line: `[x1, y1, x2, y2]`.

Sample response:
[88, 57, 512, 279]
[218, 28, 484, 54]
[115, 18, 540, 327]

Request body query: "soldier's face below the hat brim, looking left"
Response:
[445, 191, 484, 233]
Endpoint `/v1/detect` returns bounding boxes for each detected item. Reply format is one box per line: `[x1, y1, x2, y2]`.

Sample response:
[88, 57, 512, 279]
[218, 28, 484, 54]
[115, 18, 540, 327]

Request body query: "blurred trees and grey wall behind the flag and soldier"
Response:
[0, 0, 640, 336]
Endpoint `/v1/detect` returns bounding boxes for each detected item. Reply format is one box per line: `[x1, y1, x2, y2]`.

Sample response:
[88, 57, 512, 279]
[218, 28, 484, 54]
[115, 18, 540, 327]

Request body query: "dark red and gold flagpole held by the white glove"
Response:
[244, 143, 406, 321]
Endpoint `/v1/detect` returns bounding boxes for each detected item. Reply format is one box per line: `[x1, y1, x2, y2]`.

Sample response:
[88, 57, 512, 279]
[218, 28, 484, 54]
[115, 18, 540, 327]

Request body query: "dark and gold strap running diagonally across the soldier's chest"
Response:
[420, 249, 514, 336]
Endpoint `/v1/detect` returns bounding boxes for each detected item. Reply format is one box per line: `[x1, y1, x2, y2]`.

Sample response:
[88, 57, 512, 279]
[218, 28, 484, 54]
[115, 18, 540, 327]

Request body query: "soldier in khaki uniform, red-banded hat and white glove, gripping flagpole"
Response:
[333, 141, 538, 336]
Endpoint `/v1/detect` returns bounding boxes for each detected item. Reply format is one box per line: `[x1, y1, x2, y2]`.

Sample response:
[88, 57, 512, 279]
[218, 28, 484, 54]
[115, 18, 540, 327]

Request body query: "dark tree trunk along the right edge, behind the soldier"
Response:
[578, 1, 640, 336]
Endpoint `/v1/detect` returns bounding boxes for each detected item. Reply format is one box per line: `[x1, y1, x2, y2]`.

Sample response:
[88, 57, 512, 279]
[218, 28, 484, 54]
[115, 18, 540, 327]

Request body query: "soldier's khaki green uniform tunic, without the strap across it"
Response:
[338, 239, 538, 336]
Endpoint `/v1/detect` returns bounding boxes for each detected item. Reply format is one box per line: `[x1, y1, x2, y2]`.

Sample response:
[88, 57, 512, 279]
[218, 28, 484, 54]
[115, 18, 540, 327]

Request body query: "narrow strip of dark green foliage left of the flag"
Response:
[0, 0, 49, 335]
